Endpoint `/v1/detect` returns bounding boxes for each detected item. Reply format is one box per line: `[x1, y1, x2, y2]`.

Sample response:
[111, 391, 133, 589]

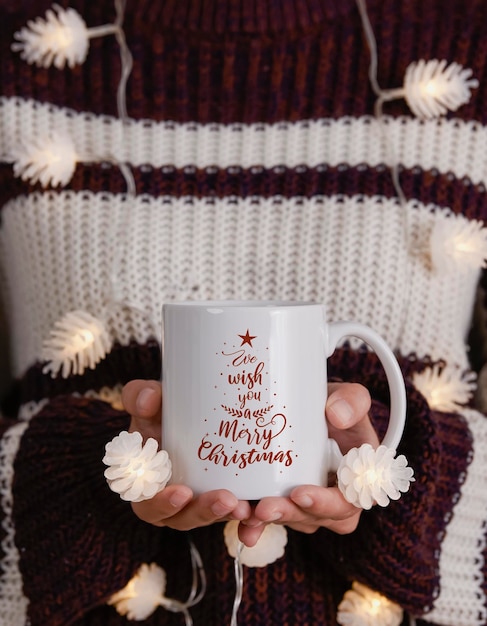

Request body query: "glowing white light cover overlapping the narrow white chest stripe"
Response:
[12, 132, 78, 187]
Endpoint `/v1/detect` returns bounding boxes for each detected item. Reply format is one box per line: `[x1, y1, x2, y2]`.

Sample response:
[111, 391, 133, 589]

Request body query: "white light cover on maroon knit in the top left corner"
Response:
[12, 4, 89, 69]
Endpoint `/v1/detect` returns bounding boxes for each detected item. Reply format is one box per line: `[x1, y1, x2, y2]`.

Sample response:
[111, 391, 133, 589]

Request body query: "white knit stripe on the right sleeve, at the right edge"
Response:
[422, 409, 487, 626]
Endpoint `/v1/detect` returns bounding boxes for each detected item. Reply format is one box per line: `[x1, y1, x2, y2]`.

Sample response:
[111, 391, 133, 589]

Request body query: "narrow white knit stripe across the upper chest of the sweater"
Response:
[0, 97, 487, 184]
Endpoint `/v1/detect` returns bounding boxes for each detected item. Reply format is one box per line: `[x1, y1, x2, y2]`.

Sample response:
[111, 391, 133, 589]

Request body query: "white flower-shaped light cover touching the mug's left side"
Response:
[103, 430, 172, 502]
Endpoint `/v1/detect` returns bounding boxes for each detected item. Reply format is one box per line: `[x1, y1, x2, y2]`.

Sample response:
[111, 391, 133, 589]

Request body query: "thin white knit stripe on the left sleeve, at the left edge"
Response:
[0, 422, 28, 626]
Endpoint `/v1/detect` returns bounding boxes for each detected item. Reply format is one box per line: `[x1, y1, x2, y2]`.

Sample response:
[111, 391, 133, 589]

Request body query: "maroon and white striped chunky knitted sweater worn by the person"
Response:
[0, 0, 487, 626]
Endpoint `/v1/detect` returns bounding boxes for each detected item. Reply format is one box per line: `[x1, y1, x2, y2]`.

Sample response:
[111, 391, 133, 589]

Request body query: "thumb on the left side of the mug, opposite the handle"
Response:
[122, 380, 162, 441]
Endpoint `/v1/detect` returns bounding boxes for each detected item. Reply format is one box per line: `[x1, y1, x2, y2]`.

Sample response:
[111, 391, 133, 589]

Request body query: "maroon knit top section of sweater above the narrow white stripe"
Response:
[0, 0, 487, 123]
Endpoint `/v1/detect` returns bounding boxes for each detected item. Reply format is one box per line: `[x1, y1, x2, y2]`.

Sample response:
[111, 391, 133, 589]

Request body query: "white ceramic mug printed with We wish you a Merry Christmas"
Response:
[162, 301, 406, 500]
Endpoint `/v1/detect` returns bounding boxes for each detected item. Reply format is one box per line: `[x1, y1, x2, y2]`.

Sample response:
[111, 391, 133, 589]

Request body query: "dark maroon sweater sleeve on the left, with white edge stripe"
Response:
[0, 396, 166, 626]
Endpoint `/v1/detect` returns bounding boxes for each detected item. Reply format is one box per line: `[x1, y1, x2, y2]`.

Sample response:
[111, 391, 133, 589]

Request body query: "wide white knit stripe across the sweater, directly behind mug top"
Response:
[0, 192, 479, 375]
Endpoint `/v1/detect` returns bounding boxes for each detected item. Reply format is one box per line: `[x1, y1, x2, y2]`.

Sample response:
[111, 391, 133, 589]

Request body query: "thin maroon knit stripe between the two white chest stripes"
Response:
[0, 164, 487, 220]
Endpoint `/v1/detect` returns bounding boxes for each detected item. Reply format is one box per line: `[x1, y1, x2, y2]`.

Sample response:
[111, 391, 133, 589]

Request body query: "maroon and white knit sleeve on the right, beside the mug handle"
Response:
[320, 348, 487, 625]
